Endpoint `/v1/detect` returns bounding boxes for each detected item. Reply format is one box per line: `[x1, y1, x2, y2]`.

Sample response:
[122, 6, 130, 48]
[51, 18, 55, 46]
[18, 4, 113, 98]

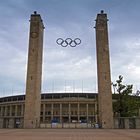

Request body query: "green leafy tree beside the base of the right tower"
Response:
[112, 75, 140, 117]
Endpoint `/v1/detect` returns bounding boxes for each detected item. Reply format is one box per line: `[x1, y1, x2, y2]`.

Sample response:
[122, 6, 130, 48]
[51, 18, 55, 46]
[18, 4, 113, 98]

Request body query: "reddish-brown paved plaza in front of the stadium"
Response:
[0, 129, 140, 140]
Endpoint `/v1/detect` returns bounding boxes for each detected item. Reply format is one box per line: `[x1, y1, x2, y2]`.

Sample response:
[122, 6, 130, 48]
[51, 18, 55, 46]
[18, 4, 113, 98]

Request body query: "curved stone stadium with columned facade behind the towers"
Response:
[0, 93, 98, 128]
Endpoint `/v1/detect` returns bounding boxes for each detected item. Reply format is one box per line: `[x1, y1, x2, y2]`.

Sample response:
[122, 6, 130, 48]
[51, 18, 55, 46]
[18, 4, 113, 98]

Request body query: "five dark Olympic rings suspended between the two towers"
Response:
[56, 38, 81, 47]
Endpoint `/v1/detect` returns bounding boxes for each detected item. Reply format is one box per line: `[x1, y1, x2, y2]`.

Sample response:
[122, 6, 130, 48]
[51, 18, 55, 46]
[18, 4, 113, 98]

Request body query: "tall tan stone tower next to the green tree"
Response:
[95, 11, 113, 128]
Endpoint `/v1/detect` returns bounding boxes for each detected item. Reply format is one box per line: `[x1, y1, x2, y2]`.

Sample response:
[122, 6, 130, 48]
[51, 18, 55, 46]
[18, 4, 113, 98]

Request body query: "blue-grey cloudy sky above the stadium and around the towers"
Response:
[0, 0, 140, 96]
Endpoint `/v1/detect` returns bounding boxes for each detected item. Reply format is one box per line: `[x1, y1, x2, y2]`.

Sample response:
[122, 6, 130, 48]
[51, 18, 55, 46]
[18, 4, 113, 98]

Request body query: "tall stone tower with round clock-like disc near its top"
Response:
[24, 11, 44, 128]
